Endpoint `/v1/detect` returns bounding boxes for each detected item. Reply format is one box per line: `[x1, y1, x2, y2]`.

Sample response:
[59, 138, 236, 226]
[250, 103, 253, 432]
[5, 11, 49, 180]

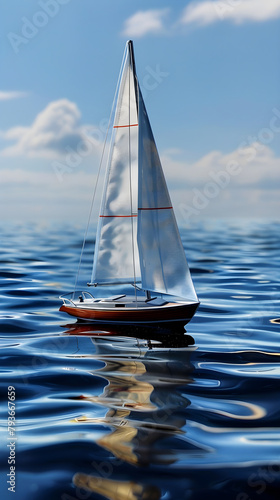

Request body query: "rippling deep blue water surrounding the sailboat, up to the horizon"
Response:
[0, 221, 280, 500]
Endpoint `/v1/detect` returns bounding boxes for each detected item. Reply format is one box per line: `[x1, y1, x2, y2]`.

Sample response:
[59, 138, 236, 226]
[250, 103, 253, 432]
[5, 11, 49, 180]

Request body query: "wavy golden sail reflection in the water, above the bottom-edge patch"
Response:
[78, 352, 189, 465]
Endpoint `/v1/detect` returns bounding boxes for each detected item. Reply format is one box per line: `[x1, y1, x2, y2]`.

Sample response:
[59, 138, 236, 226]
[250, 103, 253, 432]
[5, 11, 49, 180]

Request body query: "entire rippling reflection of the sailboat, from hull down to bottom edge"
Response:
[63, 322, 205, 500]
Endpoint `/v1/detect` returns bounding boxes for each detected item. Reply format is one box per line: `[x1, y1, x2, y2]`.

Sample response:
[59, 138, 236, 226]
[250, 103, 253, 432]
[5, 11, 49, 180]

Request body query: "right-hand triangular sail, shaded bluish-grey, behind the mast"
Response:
[137, 91, 198, 301]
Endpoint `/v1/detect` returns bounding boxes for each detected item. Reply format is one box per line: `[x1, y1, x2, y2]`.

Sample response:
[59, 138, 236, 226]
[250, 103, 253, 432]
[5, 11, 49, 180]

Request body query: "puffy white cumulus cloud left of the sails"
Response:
[1, 99, 100, 158]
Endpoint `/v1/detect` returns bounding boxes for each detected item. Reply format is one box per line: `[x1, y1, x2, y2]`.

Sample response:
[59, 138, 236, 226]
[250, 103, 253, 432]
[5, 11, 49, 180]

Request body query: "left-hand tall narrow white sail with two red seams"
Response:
[91, 45, 140, 283]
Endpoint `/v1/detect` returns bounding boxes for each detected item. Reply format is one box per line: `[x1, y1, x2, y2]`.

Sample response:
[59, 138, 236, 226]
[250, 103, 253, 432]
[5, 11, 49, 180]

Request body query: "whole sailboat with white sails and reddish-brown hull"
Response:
[60, 40, 199, 326]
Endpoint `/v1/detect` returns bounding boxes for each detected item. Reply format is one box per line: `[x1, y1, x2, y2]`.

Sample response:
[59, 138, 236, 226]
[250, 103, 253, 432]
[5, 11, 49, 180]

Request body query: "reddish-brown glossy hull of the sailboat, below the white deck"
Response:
[60, 302, 199, 325]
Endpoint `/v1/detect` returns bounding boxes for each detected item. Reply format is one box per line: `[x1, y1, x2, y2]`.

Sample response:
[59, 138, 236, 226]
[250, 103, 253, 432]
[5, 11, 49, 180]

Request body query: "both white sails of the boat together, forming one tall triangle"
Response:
[92, 42, 198, 302]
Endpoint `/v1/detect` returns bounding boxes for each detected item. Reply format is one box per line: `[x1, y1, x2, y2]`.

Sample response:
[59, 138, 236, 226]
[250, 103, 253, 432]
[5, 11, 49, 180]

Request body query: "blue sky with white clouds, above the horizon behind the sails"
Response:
[0, 0, 280, 225]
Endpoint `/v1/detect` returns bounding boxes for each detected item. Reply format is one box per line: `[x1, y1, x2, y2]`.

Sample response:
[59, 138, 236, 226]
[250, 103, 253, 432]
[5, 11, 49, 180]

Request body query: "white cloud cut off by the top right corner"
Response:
[180, 0, 280, 26]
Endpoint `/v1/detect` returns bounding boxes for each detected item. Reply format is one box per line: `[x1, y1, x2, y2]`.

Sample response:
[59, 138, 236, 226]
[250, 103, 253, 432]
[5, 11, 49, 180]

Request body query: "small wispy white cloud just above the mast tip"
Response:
[122, 9, 169, 38]
